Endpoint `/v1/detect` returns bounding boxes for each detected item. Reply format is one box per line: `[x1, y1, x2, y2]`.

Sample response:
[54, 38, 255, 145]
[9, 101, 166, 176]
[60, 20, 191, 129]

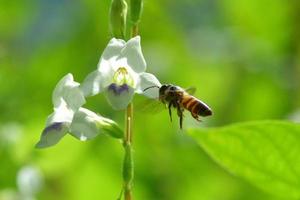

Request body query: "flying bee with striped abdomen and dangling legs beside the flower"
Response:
[143, 84, 212, 129]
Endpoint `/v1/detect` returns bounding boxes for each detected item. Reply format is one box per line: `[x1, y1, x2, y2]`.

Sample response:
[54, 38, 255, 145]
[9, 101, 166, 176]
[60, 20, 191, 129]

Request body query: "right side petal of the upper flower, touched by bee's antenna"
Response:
[136, 73, 161, 99]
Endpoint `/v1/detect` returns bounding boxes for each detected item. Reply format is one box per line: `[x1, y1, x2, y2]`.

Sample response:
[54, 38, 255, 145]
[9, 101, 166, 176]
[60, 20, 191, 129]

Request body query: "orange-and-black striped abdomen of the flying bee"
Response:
[181, 93, 212, 117]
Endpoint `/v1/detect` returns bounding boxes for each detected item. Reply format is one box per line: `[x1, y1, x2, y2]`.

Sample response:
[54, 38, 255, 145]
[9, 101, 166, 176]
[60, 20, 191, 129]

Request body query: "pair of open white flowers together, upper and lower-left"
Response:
[36, 36, 161, 148]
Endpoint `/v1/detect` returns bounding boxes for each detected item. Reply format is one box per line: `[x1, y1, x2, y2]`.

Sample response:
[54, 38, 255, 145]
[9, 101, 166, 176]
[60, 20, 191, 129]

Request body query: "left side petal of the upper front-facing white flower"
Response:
[80, 70, 102, 97]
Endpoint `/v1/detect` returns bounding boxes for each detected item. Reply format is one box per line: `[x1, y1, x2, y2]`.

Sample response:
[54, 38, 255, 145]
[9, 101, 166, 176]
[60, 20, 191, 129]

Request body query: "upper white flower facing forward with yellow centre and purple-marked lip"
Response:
[81, 36, 161, 110]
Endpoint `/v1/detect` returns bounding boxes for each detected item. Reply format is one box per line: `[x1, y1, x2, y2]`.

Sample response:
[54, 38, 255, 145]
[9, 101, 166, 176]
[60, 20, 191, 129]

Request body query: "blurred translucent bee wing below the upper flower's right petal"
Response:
[135, 96, 166, 114]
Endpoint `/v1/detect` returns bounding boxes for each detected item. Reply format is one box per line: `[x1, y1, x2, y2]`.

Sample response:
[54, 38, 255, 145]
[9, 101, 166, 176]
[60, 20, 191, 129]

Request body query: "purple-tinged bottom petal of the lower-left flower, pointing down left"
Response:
[35, 122, 69, 148]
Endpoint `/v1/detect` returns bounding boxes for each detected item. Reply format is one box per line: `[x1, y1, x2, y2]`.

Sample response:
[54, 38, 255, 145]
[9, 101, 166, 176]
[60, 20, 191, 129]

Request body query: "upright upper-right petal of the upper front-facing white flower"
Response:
[118, 36, 146, 73]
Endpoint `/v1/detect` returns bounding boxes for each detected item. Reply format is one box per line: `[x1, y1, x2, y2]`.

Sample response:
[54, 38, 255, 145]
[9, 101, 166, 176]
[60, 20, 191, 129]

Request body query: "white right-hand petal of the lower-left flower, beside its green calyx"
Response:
[70, 108, 99, 141]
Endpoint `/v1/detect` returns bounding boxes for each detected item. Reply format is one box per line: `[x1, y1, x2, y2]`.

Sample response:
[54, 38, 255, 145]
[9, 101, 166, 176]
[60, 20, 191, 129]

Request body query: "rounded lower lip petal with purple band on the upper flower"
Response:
[104, 83, 134, 110]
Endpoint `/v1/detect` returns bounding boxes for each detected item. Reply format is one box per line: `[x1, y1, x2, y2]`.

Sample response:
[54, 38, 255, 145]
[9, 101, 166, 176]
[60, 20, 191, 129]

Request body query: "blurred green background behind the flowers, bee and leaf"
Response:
[0, 0, 300, 200]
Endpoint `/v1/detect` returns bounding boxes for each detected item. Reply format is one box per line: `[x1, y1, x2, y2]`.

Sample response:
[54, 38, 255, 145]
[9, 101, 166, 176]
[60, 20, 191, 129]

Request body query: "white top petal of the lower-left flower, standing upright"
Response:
[52, 74, 85, 111]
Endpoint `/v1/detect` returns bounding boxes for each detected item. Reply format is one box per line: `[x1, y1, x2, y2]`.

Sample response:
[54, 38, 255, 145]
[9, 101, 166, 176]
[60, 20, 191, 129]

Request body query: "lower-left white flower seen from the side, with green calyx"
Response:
[36, 74, 122, 148]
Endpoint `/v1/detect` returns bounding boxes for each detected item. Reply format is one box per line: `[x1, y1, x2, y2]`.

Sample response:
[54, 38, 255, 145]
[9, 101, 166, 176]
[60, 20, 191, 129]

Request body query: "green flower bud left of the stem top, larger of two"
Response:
[110, 0, 127, 38]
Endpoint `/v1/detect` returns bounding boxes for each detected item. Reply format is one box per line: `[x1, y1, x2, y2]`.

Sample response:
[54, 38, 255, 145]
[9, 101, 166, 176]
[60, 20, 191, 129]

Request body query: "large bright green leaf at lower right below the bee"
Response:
[188, 121, 300, 199]
